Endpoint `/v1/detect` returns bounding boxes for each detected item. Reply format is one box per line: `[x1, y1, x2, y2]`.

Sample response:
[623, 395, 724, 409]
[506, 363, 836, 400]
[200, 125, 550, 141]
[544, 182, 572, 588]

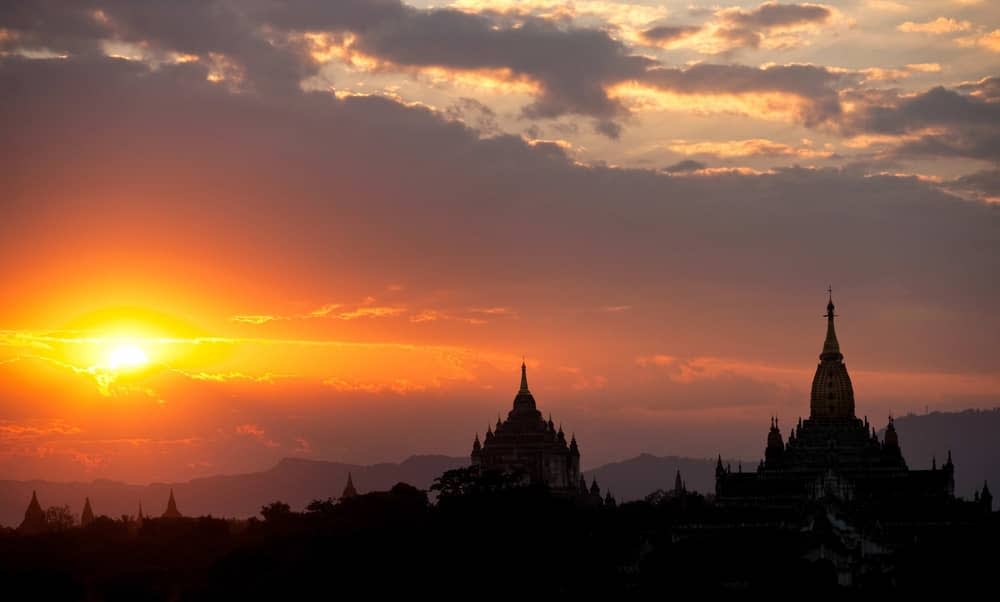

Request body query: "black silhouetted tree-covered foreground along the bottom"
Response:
[0, 474, 1000, 601]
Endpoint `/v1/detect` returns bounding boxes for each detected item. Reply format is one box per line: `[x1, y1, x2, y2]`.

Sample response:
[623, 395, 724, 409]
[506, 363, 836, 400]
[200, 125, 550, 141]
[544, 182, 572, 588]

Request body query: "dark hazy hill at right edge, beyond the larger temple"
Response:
[895, 408, 1000, 498]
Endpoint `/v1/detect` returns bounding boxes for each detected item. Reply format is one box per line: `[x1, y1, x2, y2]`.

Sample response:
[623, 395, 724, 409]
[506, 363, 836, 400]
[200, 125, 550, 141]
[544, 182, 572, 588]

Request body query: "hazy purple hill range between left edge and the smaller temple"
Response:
[0, 456, 468, 526]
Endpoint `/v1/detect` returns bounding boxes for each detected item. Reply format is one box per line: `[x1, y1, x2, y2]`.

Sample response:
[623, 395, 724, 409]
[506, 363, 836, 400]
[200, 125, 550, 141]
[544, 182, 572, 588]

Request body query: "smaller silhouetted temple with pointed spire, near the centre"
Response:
[471, 362, 584, 495]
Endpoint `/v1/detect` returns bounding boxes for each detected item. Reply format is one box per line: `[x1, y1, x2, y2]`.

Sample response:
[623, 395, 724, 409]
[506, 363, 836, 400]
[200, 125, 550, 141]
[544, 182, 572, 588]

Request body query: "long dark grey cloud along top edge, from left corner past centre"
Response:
[0, 0, 655, 134]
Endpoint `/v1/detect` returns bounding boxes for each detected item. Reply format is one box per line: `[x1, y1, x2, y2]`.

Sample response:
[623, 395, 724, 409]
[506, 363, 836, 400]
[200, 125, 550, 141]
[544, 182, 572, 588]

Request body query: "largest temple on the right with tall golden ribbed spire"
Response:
[715, 293, 955, 506]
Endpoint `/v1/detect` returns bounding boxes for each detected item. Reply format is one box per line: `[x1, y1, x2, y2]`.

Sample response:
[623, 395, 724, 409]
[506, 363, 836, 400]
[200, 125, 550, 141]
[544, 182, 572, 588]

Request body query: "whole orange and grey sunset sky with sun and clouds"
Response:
[0, 0, 1000, 483]
